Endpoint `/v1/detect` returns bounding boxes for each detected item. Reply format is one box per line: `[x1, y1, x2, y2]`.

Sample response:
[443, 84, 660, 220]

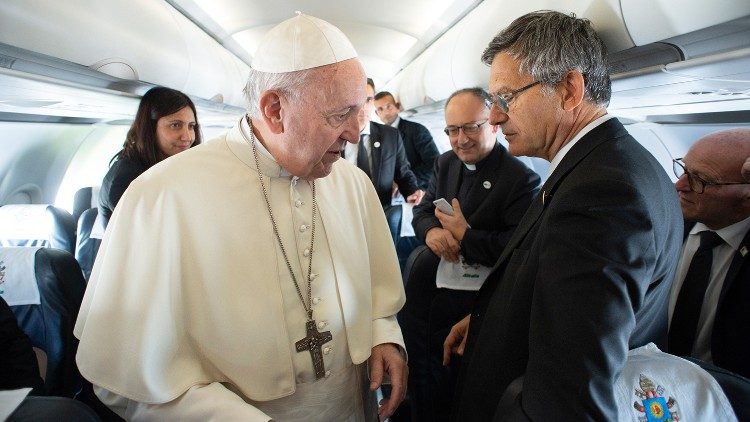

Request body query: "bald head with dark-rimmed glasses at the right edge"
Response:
[675, 129, 750, 230]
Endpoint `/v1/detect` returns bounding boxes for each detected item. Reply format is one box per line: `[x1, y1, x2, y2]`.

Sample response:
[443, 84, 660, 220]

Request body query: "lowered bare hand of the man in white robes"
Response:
[369, 343, 409, 420]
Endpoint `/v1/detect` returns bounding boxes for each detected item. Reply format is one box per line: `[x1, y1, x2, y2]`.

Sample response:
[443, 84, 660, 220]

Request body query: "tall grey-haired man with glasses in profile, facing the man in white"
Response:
[445, 11, 682, 421]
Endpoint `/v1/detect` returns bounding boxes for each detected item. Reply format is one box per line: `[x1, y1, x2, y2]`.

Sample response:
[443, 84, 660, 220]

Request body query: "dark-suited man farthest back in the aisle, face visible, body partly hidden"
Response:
[375, 91, 440, 189]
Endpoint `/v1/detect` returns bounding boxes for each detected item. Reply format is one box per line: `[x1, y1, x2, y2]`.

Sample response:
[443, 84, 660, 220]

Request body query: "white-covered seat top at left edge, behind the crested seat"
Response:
[0, 204, 76, 254]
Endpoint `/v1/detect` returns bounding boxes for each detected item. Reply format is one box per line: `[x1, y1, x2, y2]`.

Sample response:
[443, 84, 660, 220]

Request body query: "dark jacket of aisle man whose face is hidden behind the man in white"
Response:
[362, 122, 419, 207]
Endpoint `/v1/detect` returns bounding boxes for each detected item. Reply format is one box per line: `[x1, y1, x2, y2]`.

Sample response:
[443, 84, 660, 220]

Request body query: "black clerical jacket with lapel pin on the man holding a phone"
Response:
[412, 144, 539, 267]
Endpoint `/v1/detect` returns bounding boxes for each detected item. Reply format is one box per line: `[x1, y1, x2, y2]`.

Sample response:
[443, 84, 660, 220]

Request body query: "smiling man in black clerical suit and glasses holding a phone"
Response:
[406, 88, 539, 422]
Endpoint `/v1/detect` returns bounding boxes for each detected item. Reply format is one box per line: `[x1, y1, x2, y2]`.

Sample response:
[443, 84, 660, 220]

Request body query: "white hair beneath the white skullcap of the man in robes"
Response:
[242, 68, 315, 118]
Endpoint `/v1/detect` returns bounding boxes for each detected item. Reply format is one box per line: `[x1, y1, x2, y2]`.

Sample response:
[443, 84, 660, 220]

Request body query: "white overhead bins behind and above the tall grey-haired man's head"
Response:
[385, 0, 750, 109]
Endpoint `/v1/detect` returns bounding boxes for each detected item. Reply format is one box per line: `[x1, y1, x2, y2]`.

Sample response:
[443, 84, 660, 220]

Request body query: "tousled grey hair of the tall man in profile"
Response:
[482, 10, 612, 107]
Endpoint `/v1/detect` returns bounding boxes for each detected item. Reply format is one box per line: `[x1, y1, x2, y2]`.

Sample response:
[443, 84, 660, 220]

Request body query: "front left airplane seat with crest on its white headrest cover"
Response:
[0, 247, 86, 397]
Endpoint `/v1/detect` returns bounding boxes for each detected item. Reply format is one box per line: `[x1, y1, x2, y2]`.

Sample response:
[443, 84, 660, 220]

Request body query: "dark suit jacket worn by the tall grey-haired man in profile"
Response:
[452, 119, 682, 421]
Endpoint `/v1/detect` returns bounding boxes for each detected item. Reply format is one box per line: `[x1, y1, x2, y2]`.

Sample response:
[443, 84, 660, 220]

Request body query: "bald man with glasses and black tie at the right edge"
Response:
[669, 129, 750, 377]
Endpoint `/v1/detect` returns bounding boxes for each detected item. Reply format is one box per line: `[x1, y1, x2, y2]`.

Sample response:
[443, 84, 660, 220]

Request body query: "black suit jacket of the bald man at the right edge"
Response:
[685, 223, 750, 378]
